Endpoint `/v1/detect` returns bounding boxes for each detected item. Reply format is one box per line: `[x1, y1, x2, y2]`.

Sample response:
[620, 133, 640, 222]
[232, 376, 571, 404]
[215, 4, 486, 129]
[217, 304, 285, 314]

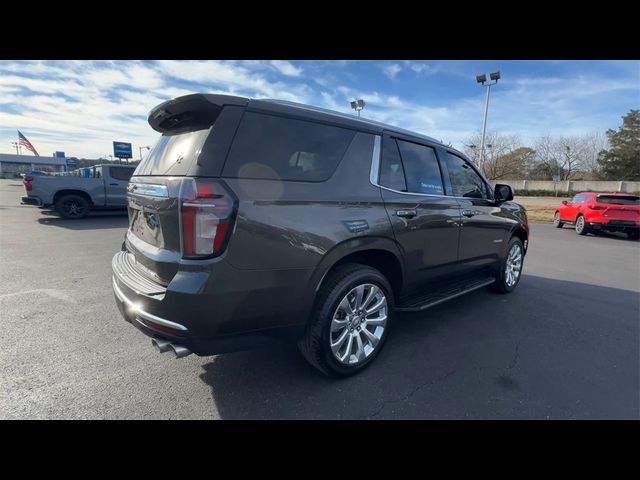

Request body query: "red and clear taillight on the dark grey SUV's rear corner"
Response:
[180, 178, 236, 258]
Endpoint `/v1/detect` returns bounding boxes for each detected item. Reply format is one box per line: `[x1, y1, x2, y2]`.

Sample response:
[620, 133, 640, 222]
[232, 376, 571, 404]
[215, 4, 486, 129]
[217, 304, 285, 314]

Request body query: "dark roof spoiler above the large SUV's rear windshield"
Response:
[149, 93, 249, 135]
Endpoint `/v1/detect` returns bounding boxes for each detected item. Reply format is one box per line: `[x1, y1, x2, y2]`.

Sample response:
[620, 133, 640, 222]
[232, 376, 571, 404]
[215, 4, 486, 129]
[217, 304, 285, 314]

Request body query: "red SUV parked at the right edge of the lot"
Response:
[553, 192, 640, 240]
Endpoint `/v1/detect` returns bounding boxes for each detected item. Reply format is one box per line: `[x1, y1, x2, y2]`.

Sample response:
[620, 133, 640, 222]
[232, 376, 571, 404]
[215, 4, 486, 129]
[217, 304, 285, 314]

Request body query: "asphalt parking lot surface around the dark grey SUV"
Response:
[0, 180, 640, 419]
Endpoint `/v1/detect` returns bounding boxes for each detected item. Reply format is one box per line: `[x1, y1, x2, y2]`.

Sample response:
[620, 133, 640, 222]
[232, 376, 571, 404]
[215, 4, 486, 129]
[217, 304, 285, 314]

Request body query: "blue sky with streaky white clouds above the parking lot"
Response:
[0, 60, 640, 158]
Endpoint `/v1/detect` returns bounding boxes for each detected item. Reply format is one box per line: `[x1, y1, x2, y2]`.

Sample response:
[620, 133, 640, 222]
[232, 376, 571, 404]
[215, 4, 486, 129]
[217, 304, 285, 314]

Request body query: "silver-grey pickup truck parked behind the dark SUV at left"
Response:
[21, 165, 135, 219]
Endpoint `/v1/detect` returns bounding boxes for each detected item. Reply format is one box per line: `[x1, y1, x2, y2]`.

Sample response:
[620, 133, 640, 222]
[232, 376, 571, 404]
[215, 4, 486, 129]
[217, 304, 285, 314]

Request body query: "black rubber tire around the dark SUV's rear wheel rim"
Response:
[298, 263, 394, 377]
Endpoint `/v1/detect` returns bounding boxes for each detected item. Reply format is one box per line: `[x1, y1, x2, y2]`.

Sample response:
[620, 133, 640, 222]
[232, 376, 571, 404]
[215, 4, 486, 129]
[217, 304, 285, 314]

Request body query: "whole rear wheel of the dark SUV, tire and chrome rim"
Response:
[298, 263, 394, 376]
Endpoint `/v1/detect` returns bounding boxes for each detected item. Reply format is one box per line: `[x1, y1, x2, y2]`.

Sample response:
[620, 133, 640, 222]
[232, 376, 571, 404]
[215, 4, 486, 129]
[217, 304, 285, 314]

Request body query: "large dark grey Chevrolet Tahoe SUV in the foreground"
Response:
[112, 94, 529, 375]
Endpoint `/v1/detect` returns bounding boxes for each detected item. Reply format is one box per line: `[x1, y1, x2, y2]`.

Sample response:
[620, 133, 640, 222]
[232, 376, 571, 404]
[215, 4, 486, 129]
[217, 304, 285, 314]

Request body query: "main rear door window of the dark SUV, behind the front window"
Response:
[398, 140, 444, 195]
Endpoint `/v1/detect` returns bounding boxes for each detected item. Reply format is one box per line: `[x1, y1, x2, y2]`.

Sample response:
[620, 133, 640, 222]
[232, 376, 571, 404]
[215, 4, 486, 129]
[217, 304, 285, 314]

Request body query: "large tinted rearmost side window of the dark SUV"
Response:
[223, 112, 356, 182]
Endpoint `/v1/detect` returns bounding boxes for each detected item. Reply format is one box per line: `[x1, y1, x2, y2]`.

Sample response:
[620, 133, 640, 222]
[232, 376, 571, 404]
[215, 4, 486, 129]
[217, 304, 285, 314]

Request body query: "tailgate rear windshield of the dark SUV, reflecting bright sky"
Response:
[134, 129, 210, 175]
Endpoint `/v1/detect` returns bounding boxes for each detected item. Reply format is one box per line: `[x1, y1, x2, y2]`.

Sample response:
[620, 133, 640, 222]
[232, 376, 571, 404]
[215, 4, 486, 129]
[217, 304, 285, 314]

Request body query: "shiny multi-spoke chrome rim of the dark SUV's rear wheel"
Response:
[329, 283, 387, 365]
